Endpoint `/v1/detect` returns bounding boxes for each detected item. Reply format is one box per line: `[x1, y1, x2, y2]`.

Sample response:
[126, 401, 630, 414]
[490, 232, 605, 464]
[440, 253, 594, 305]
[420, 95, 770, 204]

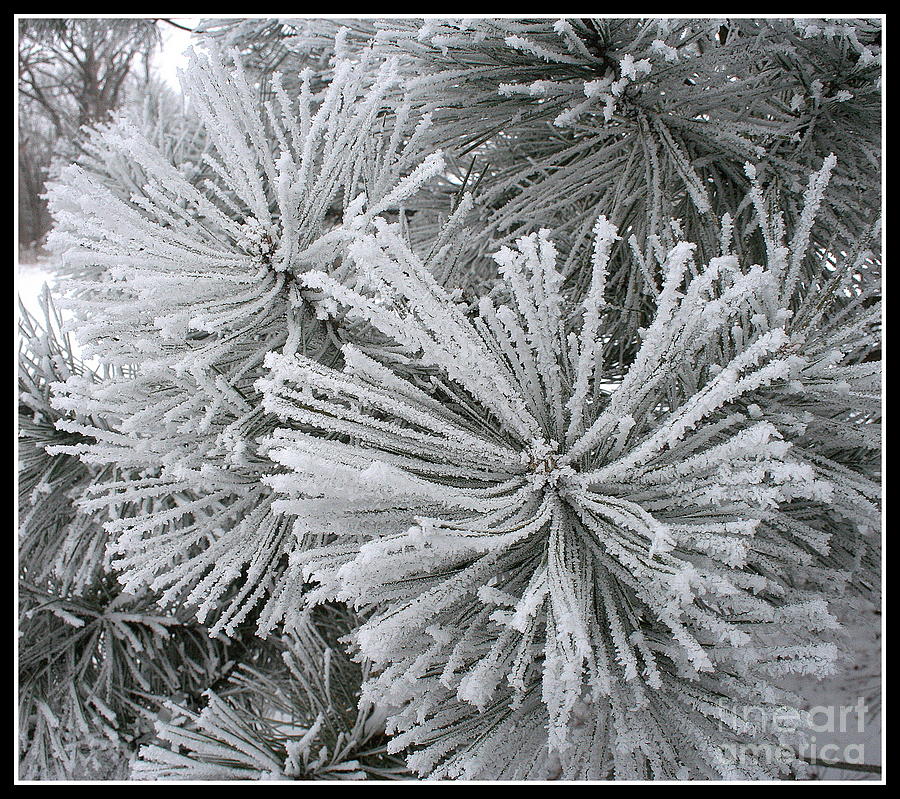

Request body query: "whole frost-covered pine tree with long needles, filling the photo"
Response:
[19, 19, 882, 780]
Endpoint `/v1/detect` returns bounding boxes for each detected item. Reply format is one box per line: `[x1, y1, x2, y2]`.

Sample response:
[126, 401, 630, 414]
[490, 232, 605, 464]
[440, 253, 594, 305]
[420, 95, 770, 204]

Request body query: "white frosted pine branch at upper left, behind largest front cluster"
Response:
[44, 43, 444, 632]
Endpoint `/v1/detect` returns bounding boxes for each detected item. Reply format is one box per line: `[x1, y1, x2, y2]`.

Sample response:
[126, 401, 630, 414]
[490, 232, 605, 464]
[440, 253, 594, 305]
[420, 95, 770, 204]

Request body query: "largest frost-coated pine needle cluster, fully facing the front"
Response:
[258, 203, 856, 775]
